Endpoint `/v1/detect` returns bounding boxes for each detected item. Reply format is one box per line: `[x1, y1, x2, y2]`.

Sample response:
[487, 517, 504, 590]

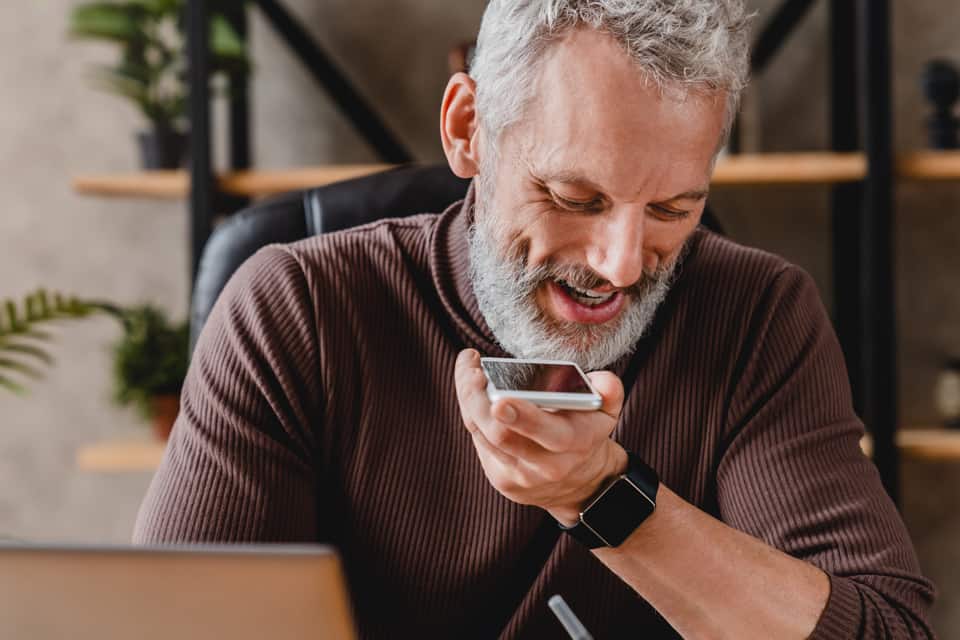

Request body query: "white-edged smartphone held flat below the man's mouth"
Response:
[480, 358, 603, 411]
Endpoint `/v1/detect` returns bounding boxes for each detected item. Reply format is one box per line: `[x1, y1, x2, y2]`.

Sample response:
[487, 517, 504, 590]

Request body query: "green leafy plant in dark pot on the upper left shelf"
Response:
[69, 0, 247, 169]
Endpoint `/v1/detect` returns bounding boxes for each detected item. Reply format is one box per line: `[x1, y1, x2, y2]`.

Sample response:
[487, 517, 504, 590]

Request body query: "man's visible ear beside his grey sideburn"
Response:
[440, 73, 480, 178]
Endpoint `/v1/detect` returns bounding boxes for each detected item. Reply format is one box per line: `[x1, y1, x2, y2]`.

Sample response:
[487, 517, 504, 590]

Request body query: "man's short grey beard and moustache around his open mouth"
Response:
[469, 185, 683, 371]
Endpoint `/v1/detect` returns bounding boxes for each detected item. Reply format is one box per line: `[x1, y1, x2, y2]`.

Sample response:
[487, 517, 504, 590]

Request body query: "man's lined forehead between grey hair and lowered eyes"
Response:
[515, 29, 725, 201]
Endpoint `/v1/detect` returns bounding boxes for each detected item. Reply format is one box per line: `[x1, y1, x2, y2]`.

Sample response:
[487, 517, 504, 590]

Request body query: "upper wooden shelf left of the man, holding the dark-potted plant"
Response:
[72, 164, 392, 199]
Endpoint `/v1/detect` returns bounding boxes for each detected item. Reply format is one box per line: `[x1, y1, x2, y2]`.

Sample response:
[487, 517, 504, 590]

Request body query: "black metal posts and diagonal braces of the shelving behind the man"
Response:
[187, 0, 899, 500]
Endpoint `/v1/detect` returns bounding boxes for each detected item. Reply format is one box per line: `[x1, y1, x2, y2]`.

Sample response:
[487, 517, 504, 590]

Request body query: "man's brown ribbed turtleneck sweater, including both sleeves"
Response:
[134, 194, 933, 639]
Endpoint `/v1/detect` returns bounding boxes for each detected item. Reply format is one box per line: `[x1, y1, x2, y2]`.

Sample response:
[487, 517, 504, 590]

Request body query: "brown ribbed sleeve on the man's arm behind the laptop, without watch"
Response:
[133, 245, 322, 544]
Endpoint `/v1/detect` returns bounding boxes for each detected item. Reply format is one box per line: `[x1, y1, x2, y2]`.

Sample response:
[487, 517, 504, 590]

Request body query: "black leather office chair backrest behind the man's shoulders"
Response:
[190, 166, 720, 352]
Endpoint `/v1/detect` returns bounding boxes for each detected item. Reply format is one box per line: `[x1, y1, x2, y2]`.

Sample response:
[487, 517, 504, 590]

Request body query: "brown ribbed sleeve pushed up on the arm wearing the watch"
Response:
[717, 267, 934, 639]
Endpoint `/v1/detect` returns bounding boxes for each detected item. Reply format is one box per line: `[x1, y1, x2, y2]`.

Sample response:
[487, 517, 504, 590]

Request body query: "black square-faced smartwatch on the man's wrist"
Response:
[560, 451, 660, 549]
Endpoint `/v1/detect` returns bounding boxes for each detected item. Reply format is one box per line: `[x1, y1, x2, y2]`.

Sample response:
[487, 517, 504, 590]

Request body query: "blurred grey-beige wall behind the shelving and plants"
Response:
[0, 0, 960, 637]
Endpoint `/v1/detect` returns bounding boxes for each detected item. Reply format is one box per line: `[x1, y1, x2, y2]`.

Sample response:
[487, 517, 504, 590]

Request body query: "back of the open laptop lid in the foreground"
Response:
[0, 545, 355, 640]
